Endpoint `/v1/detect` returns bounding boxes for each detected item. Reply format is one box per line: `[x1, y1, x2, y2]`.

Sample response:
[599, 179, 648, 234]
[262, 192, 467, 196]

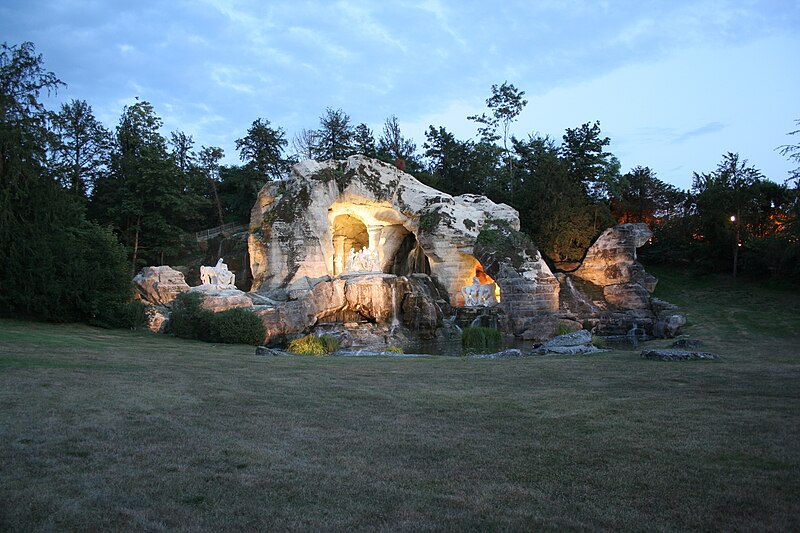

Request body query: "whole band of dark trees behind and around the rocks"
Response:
[0, 43, 800, 320]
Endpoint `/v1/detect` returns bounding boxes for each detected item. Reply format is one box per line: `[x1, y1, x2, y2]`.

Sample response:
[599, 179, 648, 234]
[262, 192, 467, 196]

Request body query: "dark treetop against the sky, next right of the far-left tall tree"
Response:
[52, 100, 111, 198]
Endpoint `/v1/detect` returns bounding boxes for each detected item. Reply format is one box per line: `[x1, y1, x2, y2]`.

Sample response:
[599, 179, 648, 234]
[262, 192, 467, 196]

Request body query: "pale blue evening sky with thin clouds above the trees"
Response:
[0, 0, 800, 188]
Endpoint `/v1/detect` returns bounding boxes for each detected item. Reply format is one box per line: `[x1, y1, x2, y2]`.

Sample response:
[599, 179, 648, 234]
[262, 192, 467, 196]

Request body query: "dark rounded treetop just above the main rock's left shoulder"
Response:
[236, 118, 291, 179]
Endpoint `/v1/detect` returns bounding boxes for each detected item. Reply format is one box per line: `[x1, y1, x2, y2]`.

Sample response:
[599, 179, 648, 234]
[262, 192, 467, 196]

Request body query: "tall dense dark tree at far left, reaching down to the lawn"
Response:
[0, 43, 130, 321]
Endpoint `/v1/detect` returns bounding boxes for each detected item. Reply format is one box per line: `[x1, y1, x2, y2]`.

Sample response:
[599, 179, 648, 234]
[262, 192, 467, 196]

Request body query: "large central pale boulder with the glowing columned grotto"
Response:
[249, 156, 559, 337]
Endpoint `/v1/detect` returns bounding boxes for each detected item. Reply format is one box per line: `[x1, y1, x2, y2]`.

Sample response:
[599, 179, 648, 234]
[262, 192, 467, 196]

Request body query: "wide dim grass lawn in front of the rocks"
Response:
[0, 271, 800, 531]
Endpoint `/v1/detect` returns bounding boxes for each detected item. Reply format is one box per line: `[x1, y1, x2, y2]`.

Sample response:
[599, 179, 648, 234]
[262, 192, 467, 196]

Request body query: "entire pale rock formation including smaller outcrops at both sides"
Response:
[135, 156, 685, 344]
